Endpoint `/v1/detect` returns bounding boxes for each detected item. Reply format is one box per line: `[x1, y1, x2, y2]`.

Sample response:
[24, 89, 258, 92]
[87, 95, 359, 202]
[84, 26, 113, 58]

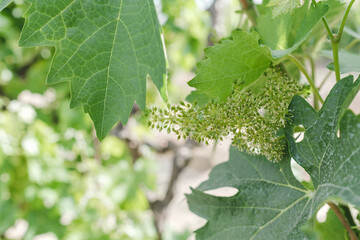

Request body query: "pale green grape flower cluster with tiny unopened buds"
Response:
[147, 68, 309, 161]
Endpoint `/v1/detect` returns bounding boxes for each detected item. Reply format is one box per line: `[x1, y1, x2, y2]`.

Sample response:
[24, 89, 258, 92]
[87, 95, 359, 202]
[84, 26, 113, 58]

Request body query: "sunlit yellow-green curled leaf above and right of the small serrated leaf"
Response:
[257, 0, 329, 59]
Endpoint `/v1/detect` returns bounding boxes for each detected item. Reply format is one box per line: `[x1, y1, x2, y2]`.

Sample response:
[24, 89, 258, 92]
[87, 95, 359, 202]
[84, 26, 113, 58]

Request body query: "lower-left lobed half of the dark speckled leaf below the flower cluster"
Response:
[187, 148, 310, 240]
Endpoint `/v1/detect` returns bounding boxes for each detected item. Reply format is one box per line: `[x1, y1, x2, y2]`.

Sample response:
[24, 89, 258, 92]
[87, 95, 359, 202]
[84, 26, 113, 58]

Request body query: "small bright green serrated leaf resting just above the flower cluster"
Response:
[189, 31, 272, 100]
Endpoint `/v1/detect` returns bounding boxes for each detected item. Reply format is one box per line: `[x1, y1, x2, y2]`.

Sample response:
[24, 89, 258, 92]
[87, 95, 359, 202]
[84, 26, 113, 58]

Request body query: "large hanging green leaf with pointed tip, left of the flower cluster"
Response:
[20, 0, 166, 139]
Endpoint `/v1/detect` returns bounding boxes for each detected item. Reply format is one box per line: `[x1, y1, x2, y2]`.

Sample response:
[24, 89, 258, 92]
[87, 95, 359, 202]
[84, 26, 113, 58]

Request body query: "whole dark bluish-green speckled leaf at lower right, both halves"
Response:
[187, 76, 360, 240]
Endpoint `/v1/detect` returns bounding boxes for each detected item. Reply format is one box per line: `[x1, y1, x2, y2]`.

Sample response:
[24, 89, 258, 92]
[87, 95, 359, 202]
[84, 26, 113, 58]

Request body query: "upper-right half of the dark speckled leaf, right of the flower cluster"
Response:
[286, 75, 360, 189]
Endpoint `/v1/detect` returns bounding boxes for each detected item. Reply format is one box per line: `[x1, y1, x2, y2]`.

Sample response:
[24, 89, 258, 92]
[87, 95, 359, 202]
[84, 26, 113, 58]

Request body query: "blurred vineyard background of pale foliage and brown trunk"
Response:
[0, 0, 360, 240]
